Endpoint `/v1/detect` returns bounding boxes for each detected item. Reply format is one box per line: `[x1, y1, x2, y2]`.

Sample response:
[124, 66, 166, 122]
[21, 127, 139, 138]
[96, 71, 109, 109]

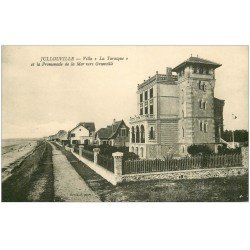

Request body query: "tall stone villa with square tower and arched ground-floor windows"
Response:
[129, 57, 224, 158]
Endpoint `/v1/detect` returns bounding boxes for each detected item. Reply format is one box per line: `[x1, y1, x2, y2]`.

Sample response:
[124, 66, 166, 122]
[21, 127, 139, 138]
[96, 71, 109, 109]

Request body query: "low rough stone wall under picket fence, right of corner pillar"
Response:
[121, 166, 248, 182]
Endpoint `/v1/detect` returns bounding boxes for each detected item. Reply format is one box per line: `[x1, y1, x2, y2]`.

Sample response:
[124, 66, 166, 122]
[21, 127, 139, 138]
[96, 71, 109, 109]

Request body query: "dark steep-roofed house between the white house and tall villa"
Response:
[95, 119, 129, 147]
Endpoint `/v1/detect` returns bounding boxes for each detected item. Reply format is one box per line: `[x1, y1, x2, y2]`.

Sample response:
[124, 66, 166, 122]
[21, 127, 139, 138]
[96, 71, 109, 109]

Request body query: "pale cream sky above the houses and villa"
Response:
[2, 46, 248, 139]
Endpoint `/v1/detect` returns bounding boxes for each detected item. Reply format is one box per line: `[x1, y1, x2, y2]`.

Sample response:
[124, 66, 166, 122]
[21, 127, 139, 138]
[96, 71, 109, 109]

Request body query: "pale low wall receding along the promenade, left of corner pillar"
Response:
[71, 150, 119, 185]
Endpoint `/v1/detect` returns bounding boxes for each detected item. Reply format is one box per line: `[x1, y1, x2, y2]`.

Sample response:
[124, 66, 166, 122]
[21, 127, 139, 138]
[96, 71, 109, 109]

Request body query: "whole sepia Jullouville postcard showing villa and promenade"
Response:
[1, 46, 249, 202]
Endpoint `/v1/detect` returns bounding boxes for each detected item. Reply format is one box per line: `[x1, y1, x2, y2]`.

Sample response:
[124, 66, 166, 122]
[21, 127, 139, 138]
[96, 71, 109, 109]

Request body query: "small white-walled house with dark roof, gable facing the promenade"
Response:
[69, 122, 95, 145]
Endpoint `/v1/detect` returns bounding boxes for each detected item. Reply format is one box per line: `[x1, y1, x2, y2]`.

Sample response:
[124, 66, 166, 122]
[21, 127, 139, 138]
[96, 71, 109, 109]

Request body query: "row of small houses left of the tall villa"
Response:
[48, 119, 129, 147]
